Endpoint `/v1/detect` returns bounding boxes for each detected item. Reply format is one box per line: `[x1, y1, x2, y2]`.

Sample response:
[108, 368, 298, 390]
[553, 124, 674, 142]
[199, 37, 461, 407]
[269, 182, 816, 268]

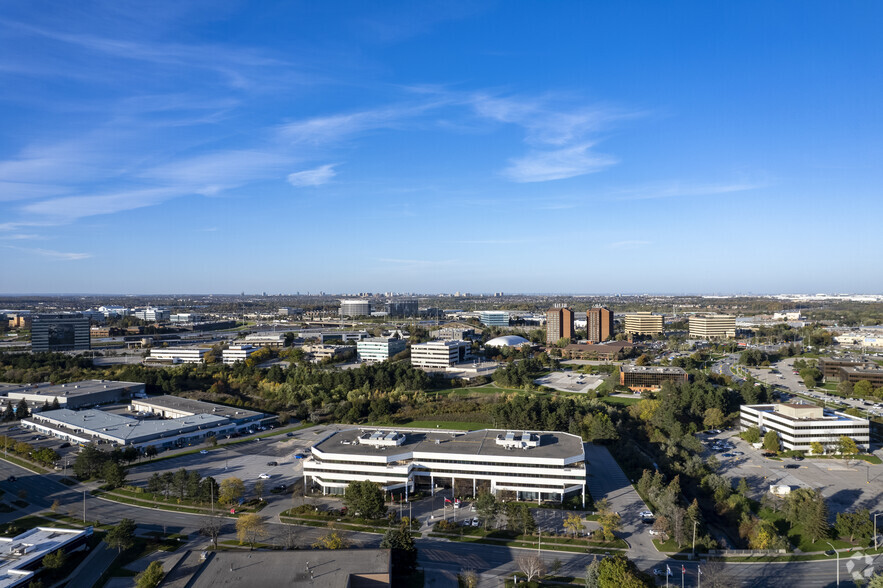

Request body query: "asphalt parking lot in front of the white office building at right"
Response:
[700, 431, 883, 513]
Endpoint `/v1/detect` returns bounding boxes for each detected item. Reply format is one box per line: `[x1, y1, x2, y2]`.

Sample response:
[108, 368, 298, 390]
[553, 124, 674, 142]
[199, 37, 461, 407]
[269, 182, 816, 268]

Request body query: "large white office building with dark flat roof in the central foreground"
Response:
[304, 429, 586, 504]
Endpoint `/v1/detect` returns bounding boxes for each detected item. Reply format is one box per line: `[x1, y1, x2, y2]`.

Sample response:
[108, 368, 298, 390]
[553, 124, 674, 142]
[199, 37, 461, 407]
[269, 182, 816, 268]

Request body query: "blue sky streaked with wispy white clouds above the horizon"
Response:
[0, 1, 883, 293]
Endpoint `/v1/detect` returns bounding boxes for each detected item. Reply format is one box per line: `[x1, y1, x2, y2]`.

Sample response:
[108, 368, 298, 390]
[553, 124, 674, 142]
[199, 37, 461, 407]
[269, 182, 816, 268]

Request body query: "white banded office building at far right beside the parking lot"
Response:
[739, 404, 870, 451]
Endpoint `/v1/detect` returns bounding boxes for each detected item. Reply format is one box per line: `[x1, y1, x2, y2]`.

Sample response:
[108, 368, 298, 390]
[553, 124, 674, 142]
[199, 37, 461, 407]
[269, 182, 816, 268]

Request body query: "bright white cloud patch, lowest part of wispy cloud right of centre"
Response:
[503, 143, 618, 182]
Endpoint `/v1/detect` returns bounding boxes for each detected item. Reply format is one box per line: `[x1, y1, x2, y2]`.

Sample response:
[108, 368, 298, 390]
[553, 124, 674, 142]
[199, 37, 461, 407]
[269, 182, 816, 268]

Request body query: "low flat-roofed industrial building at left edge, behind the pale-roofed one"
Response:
[0, 380, 145, 409]
